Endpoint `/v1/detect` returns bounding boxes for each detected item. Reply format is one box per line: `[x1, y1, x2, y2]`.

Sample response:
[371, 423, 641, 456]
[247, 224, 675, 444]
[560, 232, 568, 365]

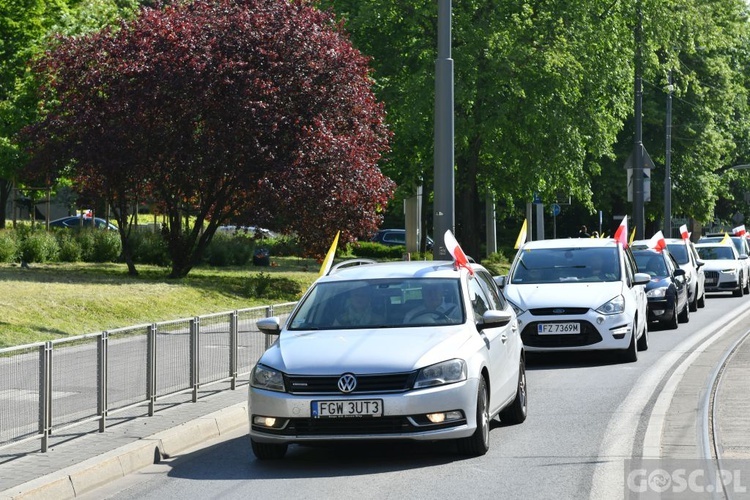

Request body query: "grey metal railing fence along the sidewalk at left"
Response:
[0, 302, 296, 452]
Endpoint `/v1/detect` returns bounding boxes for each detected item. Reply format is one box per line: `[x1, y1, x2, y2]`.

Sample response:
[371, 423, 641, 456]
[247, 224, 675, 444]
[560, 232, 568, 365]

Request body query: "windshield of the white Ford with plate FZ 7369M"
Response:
[511, 247, 620, 284]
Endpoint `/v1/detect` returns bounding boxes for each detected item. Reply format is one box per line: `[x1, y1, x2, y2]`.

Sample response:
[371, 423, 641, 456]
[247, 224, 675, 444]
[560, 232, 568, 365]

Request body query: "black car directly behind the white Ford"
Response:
[632, 245, 690, 329]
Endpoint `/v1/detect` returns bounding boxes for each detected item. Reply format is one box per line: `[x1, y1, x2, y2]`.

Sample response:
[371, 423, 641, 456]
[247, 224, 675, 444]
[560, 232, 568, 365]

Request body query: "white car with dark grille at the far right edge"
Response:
[695, 242, 748, 297]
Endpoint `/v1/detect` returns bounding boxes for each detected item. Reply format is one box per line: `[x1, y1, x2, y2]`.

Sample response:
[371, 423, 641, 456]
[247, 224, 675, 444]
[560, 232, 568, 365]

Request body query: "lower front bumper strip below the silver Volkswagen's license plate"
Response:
[253, 416, 466, 437]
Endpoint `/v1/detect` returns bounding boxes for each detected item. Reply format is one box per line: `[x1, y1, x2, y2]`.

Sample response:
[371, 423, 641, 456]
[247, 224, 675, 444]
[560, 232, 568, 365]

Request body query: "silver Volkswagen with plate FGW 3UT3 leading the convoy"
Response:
[248, 261, 527, 459]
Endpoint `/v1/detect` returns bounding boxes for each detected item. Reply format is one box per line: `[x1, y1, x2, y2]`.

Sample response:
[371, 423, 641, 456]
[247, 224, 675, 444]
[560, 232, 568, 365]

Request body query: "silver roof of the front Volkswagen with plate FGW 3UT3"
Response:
[318, 260, 472, 282]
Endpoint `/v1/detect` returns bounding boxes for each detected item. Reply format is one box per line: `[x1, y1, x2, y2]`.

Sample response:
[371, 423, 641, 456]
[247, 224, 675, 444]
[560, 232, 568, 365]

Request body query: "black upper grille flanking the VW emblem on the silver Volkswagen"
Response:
[284, 372, 417, 394]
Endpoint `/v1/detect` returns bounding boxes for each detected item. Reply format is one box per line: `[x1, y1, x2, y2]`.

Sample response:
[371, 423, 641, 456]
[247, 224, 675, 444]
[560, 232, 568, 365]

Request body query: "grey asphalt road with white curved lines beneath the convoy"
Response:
[80, 295, 750, 500]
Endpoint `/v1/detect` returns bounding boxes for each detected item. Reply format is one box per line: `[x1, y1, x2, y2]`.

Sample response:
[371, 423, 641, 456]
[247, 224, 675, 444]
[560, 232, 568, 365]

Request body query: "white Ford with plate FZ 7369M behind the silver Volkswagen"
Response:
[496, 238, 651, 362]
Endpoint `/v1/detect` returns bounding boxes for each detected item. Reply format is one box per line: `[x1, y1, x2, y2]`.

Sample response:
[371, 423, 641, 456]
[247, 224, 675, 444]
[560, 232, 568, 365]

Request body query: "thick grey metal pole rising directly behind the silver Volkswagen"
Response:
[433, 0, 455, 260]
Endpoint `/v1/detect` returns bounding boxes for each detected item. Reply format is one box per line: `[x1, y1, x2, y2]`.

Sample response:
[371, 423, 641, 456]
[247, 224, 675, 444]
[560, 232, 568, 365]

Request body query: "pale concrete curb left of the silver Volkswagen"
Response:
[0, 402, 248, 500]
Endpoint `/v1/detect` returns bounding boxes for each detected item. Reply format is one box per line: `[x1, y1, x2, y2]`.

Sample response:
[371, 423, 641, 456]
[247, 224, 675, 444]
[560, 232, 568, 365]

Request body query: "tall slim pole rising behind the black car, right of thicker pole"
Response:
[633, 0, 645, 240]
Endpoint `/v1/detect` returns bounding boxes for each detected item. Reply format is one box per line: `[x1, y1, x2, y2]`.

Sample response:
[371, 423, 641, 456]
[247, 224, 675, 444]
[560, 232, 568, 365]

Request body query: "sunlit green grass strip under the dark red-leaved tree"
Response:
[0, 257, 320, 347]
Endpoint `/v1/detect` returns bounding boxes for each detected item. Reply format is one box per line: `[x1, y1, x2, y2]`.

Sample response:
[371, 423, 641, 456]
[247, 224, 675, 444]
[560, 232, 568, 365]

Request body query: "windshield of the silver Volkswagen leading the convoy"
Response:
[288, 278, 465, 330]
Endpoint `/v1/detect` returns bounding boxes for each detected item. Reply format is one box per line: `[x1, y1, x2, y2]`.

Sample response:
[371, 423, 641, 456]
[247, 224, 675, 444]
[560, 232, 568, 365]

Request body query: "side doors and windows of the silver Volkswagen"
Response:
[469, 270, 521, 409]
